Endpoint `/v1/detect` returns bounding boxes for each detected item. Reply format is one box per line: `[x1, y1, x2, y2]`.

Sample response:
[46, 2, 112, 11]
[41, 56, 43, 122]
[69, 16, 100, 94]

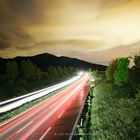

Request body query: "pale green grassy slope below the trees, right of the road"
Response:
[78, 80, 140, 140]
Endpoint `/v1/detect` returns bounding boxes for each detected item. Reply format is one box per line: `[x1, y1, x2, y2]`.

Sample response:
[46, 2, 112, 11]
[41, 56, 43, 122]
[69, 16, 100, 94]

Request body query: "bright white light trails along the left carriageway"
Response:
[0, 72, 83, 113]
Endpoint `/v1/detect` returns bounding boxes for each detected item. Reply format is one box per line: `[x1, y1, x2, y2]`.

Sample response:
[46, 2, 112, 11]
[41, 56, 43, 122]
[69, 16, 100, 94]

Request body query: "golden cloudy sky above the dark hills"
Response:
[0, 0, 140, 64]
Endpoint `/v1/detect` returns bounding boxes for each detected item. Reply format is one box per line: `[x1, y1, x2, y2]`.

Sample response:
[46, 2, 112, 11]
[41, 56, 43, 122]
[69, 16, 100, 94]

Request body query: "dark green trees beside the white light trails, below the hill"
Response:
[0, 60, 78, 101]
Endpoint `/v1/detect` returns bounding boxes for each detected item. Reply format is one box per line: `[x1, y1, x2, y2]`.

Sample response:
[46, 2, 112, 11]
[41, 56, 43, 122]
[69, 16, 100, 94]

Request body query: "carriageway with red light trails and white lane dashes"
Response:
[0, 74, 89, 140]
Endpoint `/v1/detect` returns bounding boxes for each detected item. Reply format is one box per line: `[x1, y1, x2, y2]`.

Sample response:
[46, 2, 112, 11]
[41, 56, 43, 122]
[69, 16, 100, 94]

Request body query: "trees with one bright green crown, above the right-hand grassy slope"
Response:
[105, 53, 140, 92]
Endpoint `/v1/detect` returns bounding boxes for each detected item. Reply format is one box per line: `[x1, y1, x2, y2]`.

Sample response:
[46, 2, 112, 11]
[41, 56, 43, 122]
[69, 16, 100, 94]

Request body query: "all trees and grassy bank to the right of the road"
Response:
[77, 53, 140, 140]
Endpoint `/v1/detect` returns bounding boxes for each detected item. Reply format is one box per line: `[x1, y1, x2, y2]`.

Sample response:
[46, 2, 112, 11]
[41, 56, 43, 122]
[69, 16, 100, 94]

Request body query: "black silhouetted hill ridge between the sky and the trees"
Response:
[0, 53, 106, 71]
